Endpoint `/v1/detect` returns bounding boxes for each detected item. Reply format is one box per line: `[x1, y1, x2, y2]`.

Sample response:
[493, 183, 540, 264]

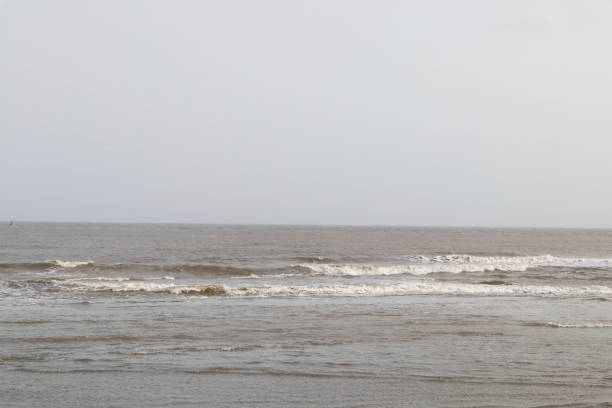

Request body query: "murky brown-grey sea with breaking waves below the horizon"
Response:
[0, 223, 612, 408]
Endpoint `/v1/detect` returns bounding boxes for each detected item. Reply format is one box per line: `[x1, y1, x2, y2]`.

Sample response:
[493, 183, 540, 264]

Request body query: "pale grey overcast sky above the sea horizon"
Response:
[0, 0, 612, 227]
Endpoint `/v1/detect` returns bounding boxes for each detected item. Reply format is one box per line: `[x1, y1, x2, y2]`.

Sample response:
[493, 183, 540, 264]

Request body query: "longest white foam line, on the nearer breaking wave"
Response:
[61, 280, 612, 297]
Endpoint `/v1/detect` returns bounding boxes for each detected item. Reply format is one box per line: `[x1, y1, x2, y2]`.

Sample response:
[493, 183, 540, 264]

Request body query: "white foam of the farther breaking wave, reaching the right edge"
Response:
[298, 255, 612, 276]
